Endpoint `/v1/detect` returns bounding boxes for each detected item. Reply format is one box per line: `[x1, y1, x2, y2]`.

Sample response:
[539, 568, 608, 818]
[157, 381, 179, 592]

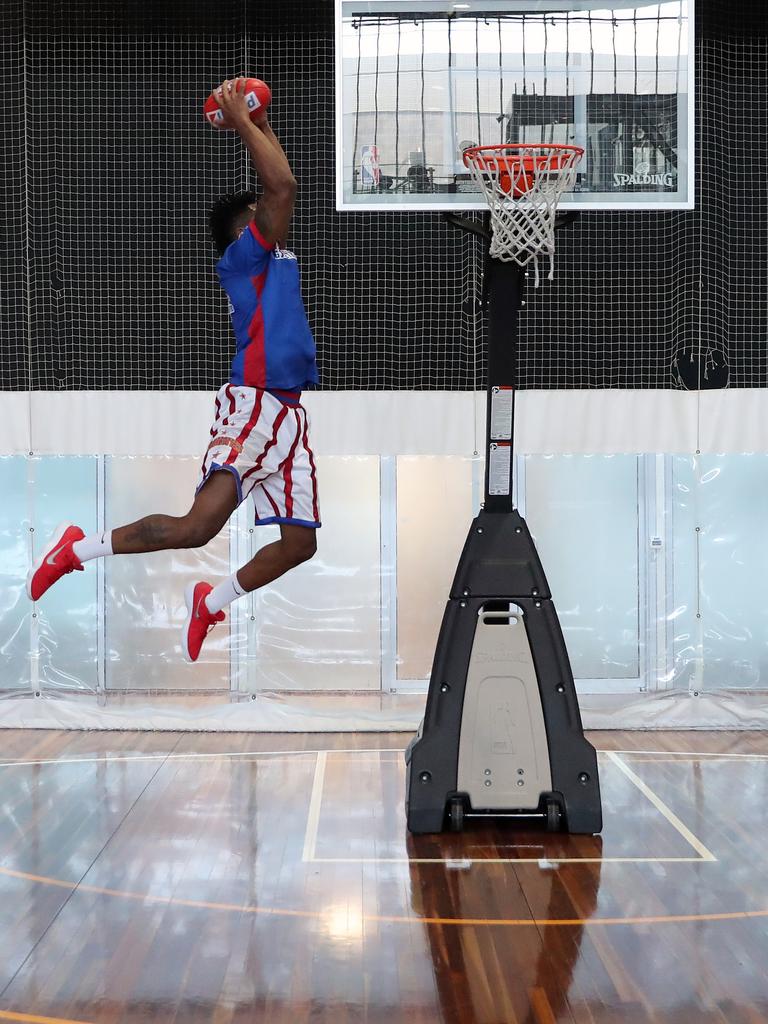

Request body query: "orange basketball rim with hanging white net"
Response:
[464, 142, 584, 288]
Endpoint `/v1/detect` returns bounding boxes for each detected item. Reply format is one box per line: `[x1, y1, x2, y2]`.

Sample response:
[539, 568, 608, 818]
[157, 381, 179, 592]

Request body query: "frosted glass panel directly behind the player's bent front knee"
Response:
[256, 457, 381, 690]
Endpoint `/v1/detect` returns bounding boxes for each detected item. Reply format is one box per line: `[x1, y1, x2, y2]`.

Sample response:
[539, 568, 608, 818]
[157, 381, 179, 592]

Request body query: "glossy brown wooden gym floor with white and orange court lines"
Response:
[0, 731, 768, 1024]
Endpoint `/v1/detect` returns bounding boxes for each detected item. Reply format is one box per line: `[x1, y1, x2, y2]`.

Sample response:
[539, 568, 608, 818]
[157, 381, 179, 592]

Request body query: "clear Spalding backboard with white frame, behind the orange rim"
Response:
[336, 0, 694, 210]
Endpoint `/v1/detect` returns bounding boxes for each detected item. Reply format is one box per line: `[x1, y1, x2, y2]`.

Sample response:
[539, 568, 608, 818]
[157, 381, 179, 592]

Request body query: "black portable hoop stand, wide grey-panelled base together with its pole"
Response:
[406, 251, 602, 833]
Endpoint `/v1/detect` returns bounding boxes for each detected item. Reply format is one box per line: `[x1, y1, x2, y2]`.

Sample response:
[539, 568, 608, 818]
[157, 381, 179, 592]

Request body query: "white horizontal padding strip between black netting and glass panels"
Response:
[0, 388, 768, 456]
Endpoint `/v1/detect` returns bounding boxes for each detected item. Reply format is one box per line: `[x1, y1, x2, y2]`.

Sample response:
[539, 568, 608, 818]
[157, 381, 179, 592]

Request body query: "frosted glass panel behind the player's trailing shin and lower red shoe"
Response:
[104, 458, 230, 690]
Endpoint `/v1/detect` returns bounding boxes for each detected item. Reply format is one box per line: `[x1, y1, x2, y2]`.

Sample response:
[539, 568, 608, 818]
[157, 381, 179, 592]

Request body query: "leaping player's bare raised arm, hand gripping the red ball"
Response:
[219, 78, 296, 245]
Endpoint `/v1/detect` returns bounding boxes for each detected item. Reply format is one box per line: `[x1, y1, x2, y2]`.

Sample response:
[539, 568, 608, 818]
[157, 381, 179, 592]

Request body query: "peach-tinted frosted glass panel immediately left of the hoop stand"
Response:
[397, 456, 474, 679]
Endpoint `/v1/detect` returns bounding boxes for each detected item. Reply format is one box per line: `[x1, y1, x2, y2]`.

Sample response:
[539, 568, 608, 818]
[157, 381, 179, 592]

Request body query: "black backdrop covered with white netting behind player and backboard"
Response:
[0, 0, 768, 390]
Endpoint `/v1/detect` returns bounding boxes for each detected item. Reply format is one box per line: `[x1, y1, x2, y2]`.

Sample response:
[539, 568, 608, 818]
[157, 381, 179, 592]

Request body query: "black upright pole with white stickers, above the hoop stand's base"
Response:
[484, 256, 525, 513]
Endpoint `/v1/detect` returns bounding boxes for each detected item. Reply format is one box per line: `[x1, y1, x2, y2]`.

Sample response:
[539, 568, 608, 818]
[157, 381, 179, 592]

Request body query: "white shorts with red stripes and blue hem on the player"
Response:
[196, 384, 321, 526]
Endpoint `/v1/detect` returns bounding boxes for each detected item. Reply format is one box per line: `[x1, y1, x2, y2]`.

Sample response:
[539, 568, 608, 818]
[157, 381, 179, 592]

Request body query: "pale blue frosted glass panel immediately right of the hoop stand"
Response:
[524, 455, 641, 679]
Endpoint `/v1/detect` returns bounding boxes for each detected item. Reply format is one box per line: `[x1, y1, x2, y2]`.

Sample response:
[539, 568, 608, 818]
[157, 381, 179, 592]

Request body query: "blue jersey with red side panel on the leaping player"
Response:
[216, 221, 317, 391]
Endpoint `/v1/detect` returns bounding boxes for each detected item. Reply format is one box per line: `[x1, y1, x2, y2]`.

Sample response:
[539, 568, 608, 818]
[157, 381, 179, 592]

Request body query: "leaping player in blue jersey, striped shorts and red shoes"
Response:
[27, 79, 321, 662]
